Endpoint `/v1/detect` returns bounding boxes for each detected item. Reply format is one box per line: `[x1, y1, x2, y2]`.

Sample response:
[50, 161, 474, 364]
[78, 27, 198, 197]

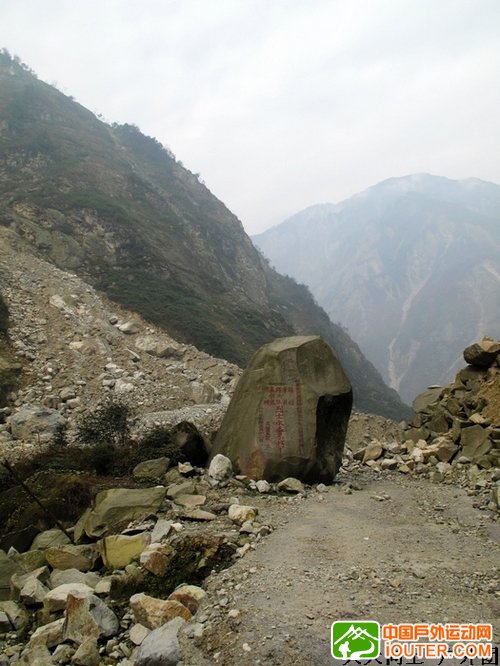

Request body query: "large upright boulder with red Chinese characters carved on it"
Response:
[212, 336, 352, 483]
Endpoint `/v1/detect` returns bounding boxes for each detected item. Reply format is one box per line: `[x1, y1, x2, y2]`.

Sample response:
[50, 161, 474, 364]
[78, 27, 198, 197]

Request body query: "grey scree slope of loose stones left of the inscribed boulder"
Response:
[0, 229, 240, 459]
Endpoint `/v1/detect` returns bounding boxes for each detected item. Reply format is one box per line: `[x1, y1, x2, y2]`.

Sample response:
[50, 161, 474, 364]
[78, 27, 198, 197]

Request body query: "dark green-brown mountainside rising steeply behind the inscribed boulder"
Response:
[0, 51, 408, 418]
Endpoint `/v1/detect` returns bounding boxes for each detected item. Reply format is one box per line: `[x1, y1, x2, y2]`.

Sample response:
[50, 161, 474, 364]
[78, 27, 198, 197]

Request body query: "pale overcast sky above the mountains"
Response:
[0, 0, 500, 233]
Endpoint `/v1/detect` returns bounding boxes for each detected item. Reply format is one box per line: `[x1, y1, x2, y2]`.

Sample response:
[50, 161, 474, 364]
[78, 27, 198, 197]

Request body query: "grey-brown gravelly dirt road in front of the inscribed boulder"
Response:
[183, 470, 500, 666]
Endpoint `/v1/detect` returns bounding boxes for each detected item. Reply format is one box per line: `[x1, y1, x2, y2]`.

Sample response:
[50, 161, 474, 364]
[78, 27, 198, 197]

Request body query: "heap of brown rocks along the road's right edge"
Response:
[352, 338, 500, 511]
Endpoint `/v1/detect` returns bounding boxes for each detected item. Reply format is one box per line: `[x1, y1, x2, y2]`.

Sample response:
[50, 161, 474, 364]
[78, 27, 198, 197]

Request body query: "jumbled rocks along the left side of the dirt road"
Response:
[0, 456, 305, 666]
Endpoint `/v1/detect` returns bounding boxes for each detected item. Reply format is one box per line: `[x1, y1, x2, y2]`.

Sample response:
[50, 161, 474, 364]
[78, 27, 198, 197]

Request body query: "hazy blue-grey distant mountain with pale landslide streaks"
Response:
[253, 174, 500, 402]
